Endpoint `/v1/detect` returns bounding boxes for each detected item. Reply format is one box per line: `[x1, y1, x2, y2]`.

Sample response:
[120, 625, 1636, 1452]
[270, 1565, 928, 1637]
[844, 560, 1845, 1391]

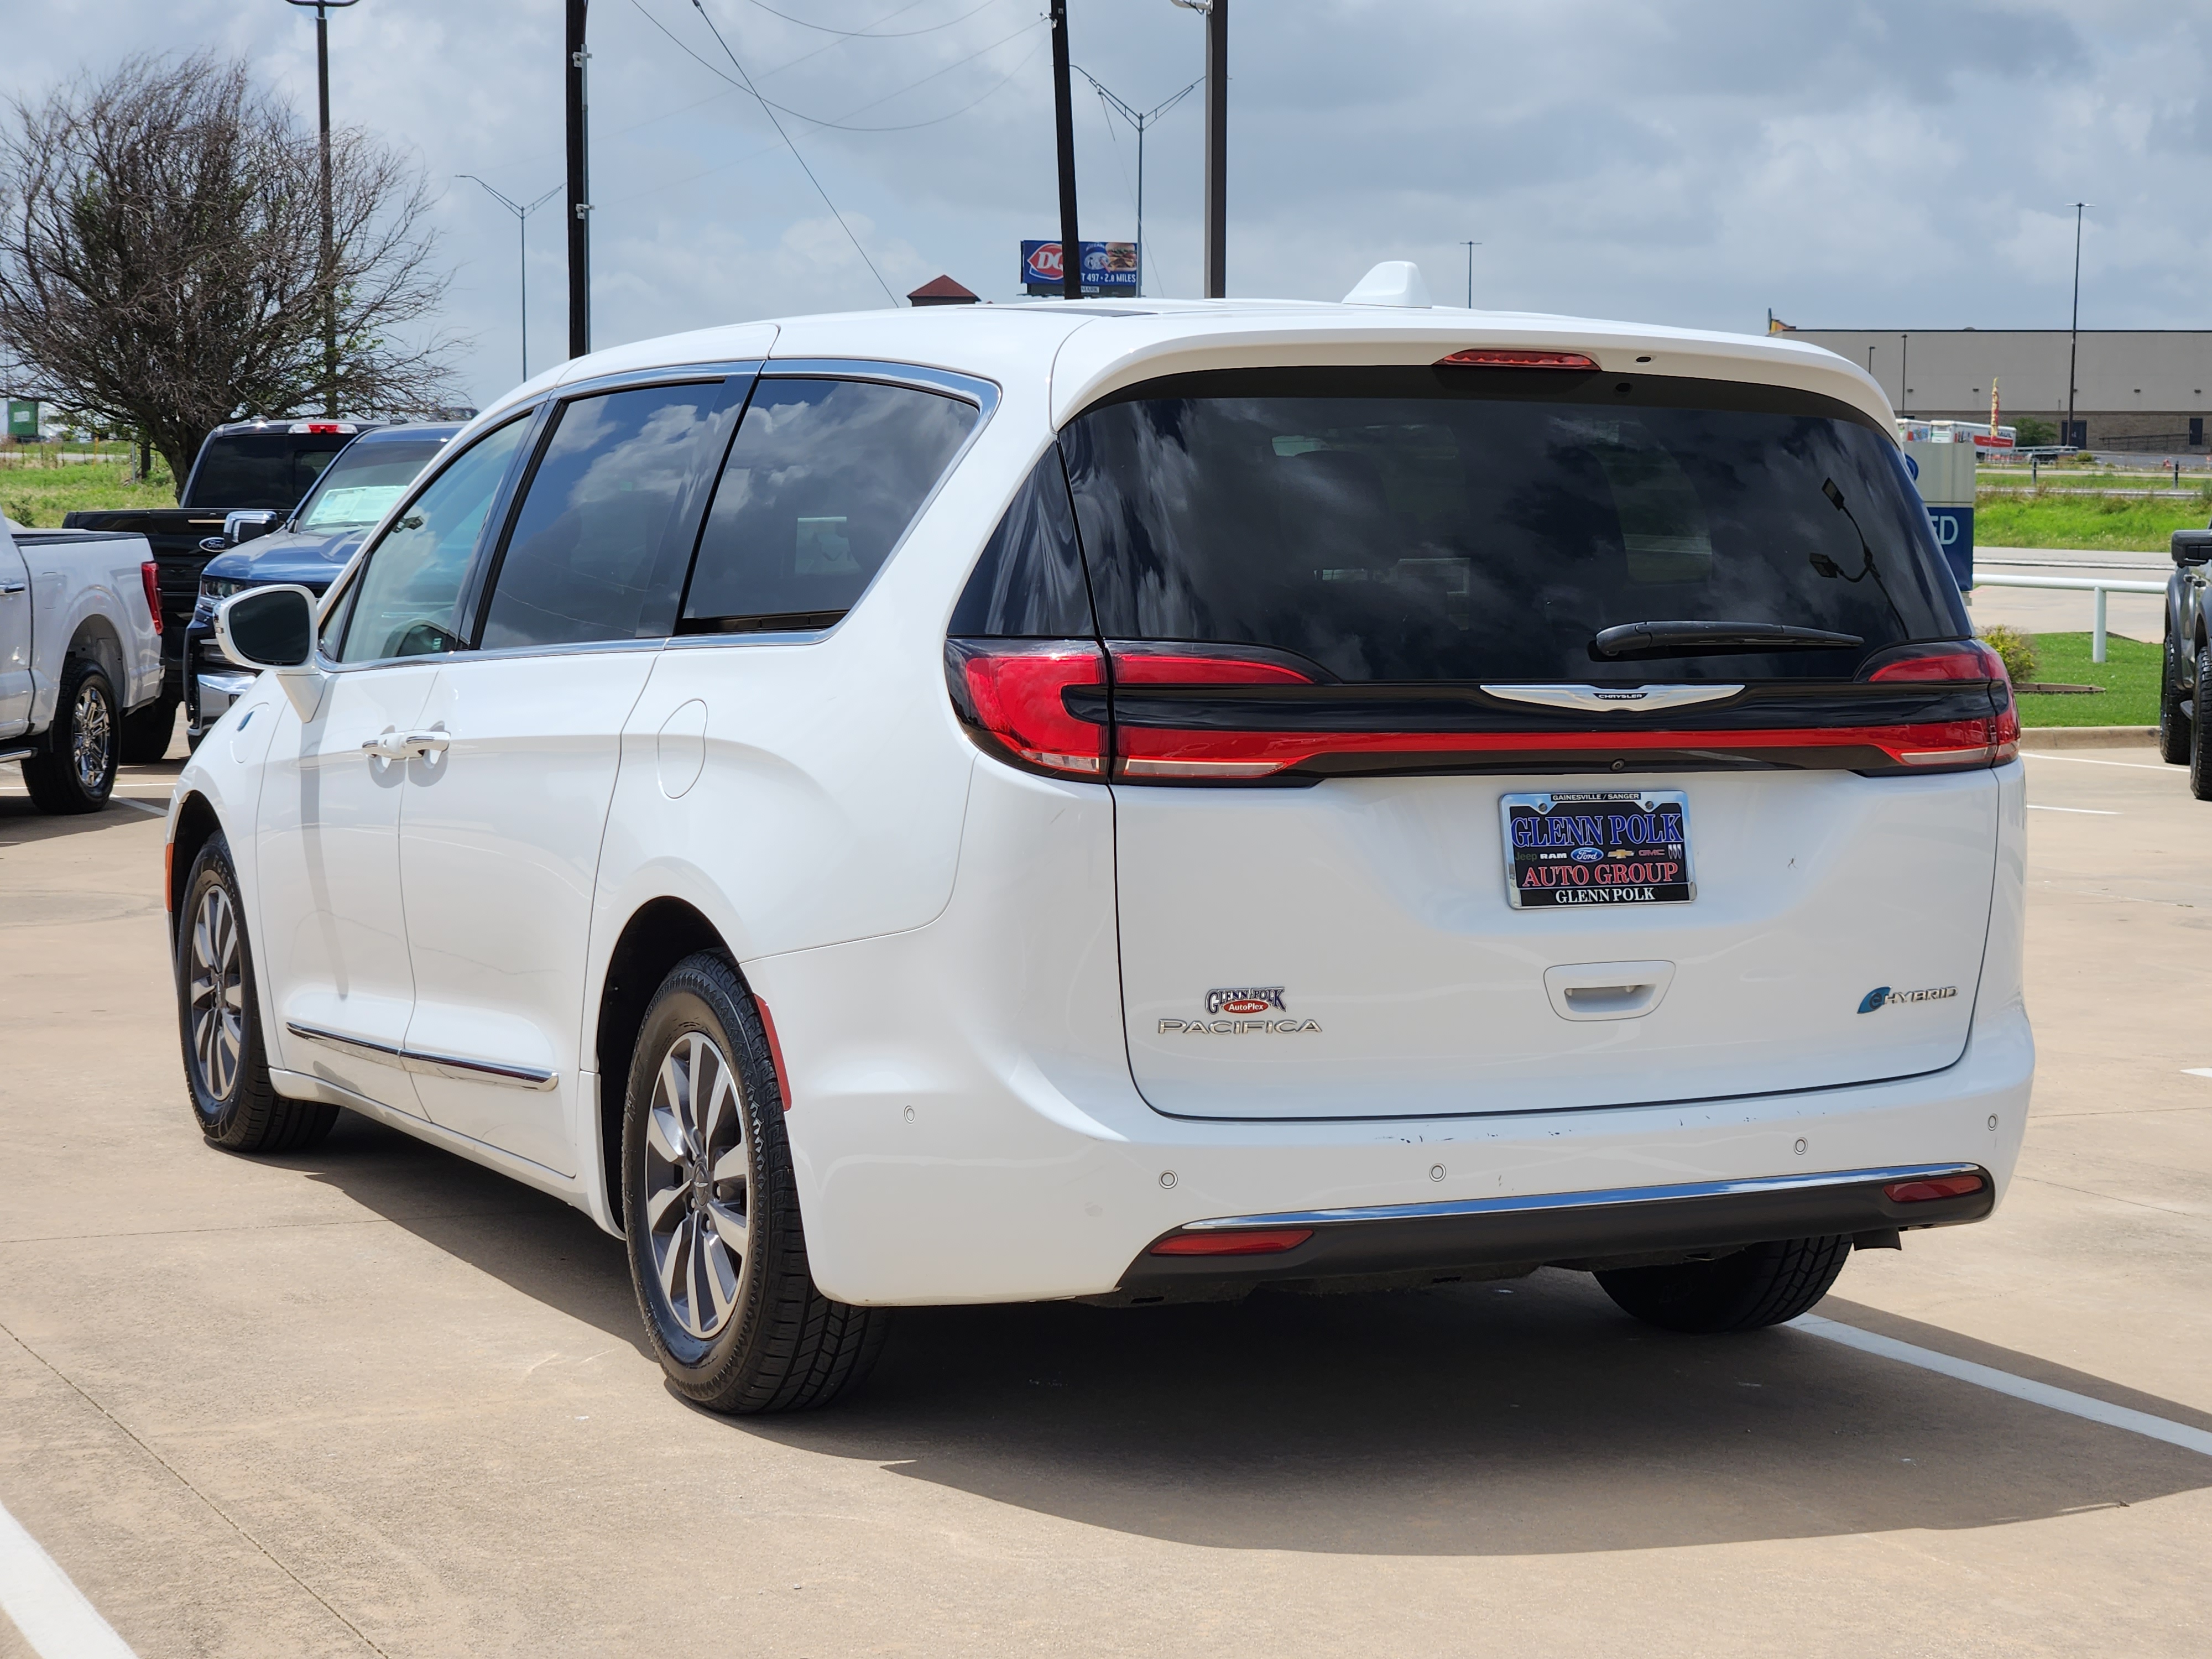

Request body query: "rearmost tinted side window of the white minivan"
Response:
[679, 378, 978, 633]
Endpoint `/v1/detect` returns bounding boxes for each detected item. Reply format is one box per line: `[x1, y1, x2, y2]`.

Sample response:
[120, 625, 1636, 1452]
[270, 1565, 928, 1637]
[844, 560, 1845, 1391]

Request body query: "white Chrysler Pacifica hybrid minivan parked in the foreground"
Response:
[168, 285, 2035, 1411]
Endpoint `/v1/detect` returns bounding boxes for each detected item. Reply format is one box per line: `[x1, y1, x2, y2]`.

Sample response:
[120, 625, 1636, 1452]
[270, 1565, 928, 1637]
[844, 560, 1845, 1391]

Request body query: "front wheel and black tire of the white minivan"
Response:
[177, 834, 338, 1152]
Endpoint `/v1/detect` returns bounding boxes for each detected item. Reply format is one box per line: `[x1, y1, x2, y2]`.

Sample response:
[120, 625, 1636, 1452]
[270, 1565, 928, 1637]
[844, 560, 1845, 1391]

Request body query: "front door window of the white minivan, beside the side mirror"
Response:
[338, 416, 531, 661]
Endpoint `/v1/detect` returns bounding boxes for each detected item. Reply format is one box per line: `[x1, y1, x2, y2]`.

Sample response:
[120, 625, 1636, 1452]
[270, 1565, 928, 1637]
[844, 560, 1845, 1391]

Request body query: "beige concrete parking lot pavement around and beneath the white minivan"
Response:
[0, 743, 2212, 1659]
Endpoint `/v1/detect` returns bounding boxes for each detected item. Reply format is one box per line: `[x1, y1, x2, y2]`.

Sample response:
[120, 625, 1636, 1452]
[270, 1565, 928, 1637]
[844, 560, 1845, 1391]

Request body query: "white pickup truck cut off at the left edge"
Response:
[0, 520, 161, 812]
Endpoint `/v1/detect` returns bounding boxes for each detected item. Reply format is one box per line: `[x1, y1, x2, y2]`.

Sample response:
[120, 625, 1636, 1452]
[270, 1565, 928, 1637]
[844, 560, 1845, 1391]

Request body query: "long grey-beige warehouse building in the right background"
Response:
[1774, 321, 2212, 453]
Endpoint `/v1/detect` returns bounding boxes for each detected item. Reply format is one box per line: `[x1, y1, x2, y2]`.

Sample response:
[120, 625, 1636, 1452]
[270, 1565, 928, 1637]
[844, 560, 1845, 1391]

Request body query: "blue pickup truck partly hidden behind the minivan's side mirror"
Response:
[184, 422, 460, 743]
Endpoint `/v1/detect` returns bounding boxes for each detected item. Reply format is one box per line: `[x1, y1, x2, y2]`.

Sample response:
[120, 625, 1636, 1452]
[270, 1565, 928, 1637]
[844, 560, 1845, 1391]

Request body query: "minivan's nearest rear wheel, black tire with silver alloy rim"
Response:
[622, 951, 889, 1416]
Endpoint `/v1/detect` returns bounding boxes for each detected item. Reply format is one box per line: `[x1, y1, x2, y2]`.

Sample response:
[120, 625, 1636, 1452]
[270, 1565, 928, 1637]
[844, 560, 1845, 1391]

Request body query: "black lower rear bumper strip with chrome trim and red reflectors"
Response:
[1119, 1164, 1997, 1303]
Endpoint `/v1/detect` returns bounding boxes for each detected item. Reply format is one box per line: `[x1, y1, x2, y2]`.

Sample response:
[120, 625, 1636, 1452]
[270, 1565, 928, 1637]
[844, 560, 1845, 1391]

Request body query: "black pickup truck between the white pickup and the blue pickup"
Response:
[62, 420, 376, 761]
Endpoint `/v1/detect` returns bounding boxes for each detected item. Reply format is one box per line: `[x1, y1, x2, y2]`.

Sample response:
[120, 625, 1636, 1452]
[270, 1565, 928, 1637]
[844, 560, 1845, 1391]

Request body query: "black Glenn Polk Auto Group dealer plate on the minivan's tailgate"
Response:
[1498, 790, 1697, 909]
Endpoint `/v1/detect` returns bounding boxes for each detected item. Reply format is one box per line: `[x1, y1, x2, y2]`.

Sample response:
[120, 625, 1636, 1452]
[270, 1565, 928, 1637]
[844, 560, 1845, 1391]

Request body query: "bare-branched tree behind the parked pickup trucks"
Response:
[0, 55, 460, 491]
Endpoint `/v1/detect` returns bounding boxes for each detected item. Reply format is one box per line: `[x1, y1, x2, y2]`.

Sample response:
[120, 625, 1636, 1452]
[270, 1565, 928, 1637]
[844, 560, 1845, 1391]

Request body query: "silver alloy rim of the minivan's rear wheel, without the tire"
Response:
[644, 1031, 752, 1340]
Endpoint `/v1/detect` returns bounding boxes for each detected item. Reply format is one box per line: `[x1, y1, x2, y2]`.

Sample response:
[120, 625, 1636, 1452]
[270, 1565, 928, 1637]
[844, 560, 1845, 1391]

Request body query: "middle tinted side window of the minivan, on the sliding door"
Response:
[482, 380, 723, 650]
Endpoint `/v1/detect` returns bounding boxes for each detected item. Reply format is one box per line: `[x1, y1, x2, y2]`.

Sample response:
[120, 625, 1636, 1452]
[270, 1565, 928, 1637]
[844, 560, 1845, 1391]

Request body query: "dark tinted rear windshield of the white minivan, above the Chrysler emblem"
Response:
[1062, 369, 1969, 684]
